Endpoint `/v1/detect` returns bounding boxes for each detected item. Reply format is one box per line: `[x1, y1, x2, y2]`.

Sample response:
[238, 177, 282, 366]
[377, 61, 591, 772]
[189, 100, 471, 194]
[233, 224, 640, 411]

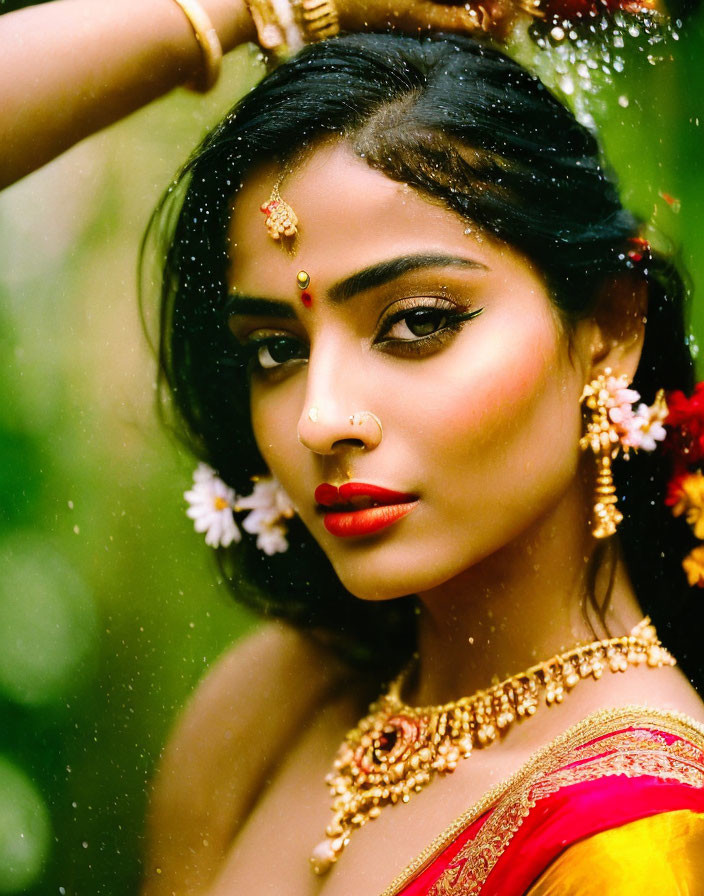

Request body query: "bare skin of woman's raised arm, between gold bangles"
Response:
[0, 0, 484, 189]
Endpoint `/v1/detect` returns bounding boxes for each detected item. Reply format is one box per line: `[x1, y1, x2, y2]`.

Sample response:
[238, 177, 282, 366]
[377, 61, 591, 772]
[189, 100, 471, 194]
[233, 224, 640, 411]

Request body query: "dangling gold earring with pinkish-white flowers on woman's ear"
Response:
[579, 368, 667, 538]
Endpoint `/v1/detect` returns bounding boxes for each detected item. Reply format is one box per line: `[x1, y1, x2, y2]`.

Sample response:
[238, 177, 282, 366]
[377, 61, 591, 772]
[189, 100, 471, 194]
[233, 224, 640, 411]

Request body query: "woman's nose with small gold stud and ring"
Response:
[298, 346, 383, 455]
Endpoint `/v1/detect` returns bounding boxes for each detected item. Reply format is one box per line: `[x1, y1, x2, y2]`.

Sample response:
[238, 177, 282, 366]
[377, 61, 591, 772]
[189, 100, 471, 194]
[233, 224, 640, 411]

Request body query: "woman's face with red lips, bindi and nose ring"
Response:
[230, 143, 587, 599]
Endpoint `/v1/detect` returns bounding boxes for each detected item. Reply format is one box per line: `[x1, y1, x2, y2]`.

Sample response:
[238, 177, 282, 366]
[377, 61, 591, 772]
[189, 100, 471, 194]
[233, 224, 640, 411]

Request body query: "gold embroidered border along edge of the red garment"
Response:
[380, 705, 704, 896]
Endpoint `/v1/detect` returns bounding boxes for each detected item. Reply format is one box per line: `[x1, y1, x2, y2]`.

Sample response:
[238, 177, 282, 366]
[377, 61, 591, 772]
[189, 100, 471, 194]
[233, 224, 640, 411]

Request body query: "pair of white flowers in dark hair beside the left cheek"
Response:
[184, 463, 295, 555]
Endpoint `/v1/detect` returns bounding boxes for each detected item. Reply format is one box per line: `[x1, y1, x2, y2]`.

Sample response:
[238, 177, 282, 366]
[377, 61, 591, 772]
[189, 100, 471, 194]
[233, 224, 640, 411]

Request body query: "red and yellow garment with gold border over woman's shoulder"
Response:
[382, 707, 704, 896]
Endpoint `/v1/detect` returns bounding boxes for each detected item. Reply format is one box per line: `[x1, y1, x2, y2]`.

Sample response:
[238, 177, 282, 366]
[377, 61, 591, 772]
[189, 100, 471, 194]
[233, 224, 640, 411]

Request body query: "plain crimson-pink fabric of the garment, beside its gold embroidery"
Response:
[399, 728, 704, 896]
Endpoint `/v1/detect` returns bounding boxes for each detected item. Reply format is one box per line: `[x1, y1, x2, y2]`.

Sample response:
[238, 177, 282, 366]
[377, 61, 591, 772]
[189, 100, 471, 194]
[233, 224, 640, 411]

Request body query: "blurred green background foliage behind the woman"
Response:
[0, 0, 704, 896]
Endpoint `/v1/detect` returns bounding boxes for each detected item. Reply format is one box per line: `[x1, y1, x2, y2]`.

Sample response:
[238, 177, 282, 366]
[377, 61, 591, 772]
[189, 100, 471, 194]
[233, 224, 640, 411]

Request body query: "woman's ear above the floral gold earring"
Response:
[574, 273, 648, 382]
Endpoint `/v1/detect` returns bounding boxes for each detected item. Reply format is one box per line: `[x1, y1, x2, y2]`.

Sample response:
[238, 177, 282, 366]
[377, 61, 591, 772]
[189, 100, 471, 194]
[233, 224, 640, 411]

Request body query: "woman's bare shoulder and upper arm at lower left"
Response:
[143, 623, 349, 896]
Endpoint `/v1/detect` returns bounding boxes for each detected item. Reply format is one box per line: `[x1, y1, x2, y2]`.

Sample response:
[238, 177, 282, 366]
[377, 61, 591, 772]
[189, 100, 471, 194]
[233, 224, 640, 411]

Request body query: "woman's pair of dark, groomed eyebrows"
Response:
[226, 253, 486, 318]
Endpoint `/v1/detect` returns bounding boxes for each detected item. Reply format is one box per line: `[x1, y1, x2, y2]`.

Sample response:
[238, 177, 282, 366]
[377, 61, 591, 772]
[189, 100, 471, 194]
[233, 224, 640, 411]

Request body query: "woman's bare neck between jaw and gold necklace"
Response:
[405, 484, 643, 705]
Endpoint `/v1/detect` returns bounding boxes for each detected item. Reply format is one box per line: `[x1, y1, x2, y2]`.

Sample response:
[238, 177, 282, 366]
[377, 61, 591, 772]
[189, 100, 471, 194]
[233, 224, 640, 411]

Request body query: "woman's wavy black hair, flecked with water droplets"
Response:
[144, 28, 702, 678]
